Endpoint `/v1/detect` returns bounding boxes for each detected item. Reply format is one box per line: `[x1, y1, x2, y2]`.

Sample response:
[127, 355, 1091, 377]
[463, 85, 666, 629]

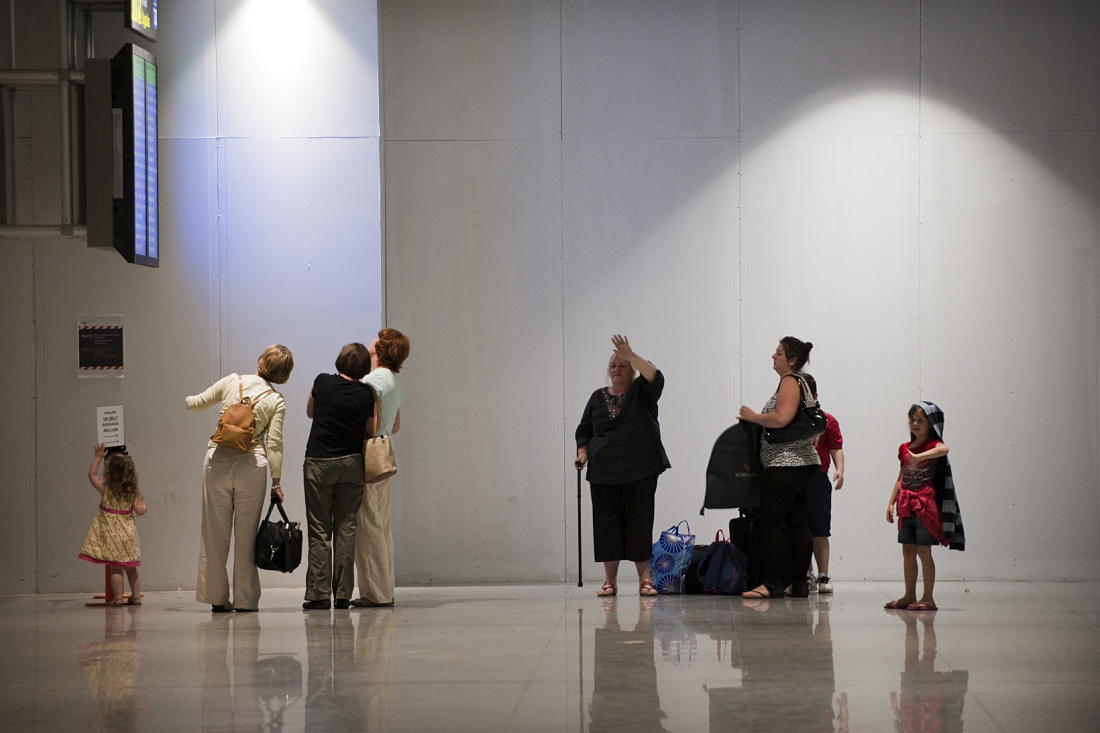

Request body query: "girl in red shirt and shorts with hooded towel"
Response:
[886, 403, 947, 611]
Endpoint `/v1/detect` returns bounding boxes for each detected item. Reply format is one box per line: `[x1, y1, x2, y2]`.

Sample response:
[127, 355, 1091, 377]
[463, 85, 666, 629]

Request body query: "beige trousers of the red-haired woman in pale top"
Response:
[355, 479, 394, 603]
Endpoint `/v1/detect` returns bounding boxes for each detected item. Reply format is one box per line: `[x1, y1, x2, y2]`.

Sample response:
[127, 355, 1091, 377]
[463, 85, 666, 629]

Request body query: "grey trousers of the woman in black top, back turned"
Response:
[303, 453, 363, 601]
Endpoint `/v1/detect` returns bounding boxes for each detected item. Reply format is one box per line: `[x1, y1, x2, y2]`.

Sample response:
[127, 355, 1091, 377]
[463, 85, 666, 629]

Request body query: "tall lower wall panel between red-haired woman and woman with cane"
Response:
[386, 142, 564, 582]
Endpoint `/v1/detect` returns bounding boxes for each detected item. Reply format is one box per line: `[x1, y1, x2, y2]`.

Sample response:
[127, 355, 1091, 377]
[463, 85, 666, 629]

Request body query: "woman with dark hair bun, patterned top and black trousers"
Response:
[738, 336, 821, 599]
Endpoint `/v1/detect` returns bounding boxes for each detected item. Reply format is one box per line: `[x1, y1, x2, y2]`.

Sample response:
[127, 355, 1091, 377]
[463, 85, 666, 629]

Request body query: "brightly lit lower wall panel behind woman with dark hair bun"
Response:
[740, 129, 921, 578]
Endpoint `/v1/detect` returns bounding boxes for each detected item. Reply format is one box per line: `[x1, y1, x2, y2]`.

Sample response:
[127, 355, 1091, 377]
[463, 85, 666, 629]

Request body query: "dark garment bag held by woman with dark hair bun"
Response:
[699, 420, 763, 514]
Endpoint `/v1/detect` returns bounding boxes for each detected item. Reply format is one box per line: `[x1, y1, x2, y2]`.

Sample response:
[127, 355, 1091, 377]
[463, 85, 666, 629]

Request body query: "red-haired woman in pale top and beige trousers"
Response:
[351, 328, 410, 608]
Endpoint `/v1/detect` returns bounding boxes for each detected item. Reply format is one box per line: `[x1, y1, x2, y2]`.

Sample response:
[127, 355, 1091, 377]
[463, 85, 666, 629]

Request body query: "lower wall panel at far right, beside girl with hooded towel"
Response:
[921, 132, 1100, 579]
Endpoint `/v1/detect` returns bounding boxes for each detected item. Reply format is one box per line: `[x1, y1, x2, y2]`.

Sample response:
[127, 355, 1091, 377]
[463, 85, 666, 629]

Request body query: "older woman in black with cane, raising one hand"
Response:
[574, 335, 670, 595]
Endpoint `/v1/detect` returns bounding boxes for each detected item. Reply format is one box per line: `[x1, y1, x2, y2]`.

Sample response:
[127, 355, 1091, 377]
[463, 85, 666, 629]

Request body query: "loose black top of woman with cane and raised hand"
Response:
[576, 371, 672, 484]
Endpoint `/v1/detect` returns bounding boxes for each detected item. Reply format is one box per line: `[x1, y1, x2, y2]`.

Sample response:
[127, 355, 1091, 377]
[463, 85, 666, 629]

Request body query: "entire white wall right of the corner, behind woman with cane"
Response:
[382, 0, 1100, 581]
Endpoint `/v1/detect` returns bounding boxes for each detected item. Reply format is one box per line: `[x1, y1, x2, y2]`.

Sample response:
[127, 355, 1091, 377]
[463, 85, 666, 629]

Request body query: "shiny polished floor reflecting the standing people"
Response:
[0, 578, 1100, 733]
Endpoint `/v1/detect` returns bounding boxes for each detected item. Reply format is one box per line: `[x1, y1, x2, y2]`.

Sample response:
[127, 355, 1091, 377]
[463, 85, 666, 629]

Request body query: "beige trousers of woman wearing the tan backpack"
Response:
[195, 447, 267, 609]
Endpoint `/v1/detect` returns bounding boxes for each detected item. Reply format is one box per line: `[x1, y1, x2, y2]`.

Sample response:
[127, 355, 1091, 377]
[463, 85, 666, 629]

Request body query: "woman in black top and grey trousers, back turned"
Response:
[301, 343, 374, 611]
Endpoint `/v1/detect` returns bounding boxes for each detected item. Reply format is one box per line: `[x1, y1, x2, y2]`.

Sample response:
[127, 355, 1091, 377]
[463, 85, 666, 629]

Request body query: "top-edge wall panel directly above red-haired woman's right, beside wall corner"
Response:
[382, 0, 561, 140]
